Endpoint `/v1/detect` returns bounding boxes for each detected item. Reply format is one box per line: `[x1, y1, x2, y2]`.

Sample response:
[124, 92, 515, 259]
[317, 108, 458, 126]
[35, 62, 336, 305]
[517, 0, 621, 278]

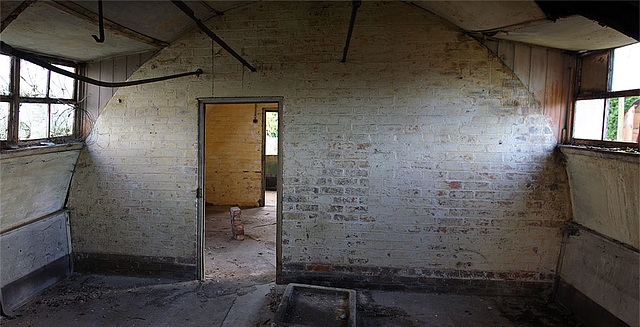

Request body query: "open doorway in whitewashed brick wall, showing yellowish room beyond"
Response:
[198, 98, 282, 282]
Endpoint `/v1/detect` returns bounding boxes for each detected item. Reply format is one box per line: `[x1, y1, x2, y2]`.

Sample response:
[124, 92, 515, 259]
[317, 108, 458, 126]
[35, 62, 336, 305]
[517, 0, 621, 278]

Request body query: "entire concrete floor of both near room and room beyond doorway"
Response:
[0, 192, 581, 327]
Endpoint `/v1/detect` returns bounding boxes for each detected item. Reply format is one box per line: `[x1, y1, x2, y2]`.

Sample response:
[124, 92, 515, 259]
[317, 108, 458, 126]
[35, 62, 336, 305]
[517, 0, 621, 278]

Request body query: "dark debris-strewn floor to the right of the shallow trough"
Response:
[357, 290, 583, 327]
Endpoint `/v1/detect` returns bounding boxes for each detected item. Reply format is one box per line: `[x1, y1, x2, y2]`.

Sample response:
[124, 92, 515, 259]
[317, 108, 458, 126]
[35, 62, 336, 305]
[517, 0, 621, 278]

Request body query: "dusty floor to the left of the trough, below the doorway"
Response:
[0, 274, 272, 327]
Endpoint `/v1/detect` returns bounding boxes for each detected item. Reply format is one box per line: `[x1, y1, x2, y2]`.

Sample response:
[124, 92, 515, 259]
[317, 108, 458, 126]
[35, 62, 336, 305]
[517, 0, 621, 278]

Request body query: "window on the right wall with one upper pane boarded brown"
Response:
[572, 43, 640, 148]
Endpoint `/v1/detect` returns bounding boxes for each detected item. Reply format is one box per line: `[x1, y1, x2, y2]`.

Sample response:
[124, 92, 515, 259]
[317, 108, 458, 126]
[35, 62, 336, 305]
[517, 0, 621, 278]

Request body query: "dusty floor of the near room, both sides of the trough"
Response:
[0, 274, 581, 327]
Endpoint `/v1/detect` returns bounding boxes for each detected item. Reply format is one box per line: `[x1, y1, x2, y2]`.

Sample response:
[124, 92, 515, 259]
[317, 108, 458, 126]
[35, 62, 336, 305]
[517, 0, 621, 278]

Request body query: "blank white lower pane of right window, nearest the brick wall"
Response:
[573, 99, 604, 140]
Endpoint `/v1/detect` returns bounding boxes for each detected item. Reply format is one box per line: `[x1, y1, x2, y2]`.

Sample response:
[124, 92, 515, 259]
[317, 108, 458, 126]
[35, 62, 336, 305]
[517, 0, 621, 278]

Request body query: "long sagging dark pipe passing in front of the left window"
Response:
[0, 41, 203, 87]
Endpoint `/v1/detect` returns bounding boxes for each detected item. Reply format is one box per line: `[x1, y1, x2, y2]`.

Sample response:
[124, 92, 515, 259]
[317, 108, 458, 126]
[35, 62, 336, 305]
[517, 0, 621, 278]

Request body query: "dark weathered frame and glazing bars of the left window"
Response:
[0, 54, 82, 150]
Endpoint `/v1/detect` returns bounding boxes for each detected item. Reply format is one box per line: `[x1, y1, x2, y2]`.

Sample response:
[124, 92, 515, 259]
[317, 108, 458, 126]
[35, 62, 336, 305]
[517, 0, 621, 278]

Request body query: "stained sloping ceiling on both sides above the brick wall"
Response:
[0, 0, 637, 62]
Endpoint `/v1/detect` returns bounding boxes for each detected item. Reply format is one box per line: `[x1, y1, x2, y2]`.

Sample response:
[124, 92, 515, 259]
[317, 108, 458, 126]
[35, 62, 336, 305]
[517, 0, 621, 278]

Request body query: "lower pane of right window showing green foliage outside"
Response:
[605, 96, 640, 142]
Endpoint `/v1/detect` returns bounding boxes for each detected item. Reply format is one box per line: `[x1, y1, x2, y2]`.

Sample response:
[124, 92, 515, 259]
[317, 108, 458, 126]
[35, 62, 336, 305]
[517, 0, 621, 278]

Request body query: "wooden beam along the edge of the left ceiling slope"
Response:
[45, 1, 169, 48]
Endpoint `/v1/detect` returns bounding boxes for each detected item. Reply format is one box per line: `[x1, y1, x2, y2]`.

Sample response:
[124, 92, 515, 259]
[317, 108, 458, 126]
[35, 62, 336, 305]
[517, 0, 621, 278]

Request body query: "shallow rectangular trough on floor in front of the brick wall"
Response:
[274, 283, 356, 327]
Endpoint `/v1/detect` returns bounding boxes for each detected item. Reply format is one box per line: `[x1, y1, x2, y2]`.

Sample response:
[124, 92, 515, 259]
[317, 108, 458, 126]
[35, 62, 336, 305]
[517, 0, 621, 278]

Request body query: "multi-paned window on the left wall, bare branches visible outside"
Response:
[0, 55, 77, 144]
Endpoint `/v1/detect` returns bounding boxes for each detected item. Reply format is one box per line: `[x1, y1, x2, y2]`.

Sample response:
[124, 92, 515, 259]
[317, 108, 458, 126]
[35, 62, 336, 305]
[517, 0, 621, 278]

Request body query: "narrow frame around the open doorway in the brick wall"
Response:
[196, 96, 284, 284]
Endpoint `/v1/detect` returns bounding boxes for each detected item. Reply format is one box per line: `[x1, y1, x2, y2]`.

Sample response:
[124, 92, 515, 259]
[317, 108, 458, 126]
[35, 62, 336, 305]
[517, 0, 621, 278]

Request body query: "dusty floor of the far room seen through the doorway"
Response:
[205, 191, 276, 283]
